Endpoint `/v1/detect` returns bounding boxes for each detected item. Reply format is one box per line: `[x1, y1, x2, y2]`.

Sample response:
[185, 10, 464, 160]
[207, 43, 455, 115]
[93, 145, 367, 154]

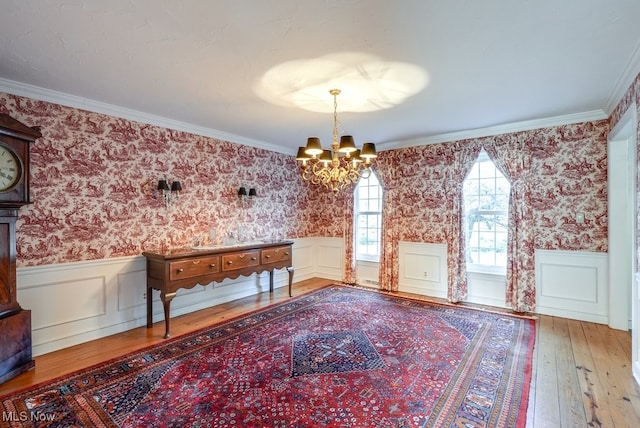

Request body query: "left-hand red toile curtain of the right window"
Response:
[447, 142, 482, 303]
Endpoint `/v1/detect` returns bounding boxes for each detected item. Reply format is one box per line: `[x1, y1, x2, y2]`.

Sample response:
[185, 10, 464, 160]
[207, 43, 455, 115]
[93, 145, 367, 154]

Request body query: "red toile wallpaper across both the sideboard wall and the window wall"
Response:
[0, 92, 608, 278]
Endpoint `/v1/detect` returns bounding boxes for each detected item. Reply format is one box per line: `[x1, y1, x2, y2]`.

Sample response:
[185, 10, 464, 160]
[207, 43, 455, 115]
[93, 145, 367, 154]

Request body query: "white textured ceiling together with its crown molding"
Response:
[0, 0, 640, 154]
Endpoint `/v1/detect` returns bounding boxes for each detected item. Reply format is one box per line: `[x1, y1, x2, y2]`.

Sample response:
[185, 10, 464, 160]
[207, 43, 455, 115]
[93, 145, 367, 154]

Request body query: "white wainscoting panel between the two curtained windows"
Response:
[398, 242, 448, 298]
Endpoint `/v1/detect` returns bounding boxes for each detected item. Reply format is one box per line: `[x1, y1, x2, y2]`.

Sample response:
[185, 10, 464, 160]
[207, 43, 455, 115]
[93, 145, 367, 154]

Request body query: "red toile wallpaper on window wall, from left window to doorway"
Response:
[377, 121, 609, 252]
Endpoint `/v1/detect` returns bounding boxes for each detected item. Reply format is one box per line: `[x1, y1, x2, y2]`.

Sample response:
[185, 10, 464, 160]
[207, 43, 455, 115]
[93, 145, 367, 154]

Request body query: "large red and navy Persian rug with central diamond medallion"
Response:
[0, 285, 535, 427]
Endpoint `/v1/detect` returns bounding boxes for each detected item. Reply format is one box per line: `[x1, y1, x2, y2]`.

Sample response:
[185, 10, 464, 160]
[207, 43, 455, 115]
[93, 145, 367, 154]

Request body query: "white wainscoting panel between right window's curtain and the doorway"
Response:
[536, 250, 609, 324]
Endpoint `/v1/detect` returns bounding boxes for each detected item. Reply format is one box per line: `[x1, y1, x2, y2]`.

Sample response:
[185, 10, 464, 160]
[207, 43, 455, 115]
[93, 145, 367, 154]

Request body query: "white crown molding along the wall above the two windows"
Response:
[376, 110, 608, 152]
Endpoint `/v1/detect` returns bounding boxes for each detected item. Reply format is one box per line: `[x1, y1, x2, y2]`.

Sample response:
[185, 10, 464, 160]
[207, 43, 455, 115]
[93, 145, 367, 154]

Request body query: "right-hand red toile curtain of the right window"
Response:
[484, 135, 535, 312]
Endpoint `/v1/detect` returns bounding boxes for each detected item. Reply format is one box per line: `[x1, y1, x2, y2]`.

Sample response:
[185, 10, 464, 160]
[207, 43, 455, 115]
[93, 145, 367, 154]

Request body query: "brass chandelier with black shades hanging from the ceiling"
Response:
[296, 89, 377, 194]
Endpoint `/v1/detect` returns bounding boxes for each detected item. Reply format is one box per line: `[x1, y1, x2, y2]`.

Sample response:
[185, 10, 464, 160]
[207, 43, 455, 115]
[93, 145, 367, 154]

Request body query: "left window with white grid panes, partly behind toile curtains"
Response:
[354, 171, 382, 262]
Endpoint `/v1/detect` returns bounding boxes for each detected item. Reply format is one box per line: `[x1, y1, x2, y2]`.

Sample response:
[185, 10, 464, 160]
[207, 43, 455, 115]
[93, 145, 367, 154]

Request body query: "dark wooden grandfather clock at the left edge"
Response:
[0, 114, 42, 383]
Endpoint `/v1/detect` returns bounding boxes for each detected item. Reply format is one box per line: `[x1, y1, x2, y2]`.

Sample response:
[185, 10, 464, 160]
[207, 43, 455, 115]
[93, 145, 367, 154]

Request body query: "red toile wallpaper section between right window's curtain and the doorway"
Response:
[528, 120, 609, 252]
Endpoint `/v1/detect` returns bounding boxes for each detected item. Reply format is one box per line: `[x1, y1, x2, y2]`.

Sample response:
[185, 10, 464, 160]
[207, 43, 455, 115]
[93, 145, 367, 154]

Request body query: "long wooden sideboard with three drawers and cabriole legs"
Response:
[142, 241, 293, 339]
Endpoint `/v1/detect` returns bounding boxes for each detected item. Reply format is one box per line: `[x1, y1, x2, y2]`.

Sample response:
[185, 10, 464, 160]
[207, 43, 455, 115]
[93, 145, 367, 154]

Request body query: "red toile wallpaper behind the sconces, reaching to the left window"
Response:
[0, 94, 342, 266]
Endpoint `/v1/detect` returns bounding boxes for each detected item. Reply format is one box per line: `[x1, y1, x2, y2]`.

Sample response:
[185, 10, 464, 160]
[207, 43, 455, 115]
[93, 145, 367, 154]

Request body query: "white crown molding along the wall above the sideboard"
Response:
[0, 78, 291, 155]
